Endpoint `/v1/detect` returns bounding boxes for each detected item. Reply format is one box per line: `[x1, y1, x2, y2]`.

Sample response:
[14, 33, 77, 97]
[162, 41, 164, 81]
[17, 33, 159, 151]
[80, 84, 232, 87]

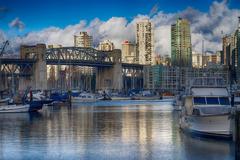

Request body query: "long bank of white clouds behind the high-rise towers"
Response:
[3, 1, 240, 55]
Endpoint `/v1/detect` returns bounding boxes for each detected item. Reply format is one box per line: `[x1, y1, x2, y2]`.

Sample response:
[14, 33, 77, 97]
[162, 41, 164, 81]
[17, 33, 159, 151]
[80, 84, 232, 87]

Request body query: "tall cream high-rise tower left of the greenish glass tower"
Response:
[136, 19, 154, 64]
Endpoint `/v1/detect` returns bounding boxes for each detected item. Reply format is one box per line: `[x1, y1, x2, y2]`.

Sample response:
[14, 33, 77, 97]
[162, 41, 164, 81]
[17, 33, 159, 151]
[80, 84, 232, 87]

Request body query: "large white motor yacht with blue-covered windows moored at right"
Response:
[180, 77, 232, 138]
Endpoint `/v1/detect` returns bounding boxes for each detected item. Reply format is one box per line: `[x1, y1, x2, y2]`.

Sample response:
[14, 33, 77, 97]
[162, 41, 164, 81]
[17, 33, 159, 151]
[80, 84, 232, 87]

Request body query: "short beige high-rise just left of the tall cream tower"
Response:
[122, 40, 137, 63]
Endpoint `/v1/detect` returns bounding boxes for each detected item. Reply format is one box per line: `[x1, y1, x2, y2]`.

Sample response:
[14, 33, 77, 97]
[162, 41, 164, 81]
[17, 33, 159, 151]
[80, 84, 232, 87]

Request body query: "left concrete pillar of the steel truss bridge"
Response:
[19, 44, 47, 90]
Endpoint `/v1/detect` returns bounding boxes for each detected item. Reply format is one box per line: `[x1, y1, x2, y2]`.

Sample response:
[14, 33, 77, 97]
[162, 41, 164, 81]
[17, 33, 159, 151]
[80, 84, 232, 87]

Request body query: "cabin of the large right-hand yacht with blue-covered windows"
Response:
[184, 87, 231, 116]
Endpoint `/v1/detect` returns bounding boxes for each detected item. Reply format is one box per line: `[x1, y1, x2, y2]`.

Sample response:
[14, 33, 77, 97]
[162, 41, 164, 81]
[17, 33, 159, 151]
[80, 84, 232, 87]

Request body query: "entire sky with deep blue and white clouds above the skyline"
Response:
[0, 0, 240, 55]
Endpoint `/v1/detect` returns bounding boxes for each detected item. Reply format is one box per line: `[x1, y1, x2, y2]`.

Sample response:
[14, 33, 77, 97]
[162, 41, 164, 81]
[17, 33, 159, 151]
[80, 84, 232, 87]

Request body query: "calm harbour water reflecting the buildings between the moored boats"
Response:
[0, 101, 234, 160]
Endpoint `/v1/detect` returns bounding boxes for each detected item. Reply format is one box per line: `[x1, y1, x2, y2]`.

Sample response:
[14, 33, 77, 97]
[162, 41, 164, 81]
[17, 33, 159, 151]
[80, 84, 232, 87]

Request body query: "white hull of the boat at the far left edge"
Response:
[0, 104, 30, 113]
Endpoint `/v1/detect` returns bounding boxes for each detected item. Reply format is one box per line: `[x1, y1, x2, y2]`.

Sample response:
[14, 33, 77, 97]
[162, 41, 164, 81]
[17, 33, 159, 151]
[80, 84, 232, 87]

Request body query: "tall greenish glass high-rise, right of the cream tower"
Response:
[171, 18, 192, 67]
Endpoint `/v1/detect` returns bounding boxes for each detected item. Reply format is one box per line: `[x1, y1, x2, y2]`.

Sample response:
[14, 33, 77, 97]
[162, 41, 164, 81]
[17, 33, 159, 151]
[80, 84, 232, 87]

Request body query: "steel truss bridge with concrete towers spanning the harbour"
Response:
[0, 44, 143, 90]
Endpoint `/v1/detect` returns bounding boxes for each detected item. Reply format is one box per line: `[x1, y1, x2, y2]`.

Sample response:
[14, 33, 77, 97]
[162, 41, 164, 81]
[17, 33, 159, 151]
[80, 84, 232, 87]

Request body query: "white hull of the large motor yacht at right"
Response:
[180, 114, 232, 137]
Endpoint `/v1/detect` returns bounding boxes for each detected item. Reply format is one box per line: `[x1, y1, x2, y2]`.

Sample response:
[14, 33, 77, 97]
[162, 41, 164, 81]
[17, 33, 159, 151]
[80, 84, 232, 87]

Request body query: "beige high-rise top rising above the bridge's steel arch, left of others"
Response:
[74, 32, 93, 47]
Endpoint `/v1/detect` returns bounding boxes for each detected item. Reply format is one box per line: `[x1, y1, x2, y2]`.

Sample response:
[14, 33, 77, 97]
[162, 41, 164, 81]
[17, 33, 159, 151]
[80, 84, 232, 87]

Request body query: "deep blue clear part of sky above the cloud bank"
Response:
[0, 0, 240, 33]
